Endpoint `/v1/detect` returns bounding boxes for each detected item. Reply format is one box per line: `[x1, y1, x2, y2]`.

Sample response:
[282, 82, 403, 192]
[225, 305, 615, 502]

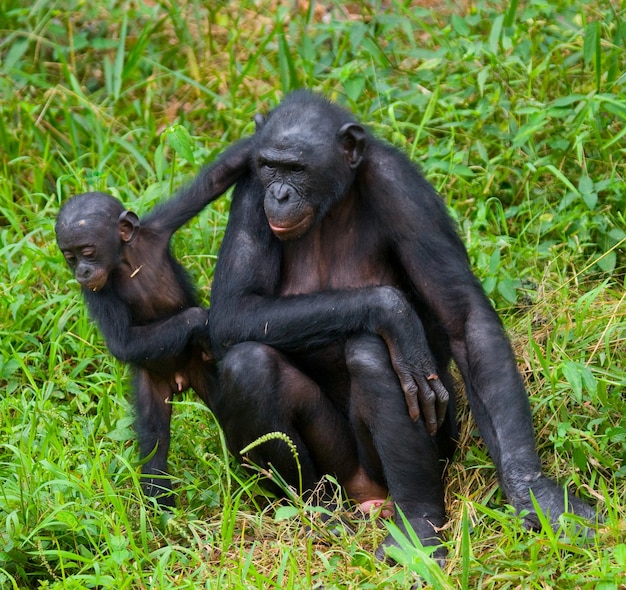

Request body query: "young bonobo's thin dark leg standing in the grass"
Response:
[135, 369, 174, 506]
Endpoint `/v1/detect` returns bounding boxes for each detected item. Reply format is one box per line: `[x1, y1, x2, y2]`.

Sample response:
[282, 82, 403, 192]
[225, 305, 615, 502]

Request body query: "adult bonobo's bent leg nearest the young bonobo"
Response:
[213, 342, 366, 491]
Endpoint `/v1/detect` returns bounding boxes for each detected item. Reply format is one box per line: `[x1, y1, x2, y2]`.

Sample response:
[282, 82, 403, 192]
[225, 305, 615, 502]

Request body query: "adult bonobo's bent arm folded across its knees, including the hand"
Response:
[210, 176, 448, 432]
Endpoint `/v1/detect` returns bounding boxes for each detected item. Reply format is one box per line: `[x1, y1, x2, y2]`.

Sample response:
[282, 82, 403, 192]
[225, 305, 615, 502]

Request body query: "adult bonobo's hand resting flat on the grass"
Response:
[507, 474, 596, 529]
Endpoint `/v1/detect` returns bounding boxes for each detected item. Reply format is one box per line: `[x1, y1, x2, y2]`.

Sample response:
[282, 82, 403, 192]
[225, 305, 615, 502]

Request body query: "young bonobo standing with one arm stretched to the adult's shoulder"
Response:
[55, 140, 250, 506]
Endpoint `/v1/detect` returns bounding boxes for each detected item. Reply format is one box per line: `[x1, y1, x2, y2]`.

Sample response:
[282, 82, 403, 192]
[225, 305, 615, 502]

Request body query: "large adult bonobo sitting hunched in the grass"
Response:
[210, 91, 594, 553]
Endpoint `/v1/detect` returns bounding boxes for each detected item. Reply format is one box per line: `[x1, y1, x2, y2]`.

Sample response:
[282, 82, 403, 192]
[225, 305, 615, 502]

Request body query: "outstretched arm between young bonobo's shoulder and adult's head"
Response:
[141, 137, 252, 235]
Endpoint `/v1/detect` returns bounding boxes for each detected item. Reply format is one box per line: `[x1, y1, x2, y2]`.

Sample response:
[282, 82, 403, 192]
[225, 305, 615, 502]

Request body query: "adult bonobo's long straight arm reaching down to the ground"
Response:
[363, 144, 563, 506]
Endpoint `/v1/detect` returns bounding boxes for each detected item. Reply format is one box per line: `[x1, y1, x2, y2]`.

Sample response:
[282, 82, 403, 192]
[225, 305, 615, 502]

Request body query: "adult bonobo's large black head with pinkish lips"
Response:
[254, 90, 367, 240]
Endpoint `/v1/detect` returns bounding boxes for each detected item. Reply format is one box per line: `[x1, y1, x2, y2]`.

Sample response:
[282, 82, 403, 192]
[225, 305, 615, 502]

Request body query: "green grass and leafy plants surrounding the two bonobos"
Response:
[0, 0, 626, 590]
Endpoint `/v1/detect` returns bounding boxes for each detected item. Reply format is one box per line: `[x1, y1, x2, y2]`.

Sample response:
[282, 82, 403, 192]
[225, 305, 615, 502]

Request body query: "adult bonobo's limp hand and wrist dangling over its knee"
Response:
[380, 287, 450, 434]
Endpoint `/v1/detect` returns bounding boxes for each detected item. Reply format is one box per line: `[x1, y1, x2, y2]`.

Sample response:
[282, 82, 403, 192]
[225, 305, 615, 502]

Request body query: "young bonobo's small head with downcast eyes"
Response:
[54, 193, 139, 291]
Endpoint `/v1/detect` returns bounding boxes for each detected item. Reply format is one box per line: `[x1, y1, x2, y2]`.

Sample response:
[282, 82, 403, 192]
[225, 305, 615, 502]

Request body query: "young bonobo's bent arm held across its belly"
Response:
[83, 287, 209, 365]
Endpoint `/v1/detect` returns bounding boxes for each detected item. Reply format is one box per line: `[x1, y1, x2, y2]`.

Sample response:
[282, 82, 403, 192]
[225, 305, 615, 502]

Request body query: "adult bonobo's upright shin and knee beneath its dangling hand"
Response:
[346, 335, 445, 557]
